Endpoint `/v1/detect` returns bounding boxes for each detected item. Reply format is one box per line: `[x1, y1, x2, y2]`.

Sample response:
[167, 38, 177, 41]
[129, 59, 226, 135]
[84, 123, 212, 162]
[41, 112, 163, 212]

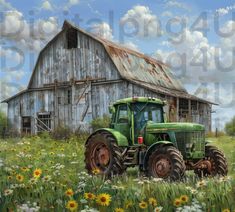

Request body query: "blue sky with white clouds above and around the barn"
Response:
[0, 0, 235, 130]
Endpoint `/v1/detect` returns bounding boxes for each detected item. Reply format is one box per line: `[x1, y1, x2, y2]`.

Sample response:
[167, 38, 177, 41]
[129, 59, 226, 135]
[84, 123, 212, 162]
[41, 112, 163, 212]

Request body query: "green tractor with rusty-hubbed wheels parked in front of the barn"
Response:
[85, 97, 228, 180]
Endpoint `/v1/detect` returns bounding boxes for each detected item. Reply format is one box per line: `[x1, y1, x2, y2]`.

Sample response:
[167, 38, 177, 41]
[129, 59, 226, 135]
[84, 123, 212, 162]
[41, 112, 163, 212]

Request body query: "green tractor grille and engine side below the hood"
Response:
[175, 131, 205, 156]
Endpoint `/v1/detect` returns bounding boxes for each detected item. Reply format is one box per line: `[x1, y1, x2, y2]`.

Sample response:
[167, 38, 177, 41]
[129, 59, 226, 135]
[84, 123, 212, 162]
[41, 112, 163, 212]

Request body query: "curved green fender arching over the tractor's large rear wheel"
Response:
[86, 128, 129, 146]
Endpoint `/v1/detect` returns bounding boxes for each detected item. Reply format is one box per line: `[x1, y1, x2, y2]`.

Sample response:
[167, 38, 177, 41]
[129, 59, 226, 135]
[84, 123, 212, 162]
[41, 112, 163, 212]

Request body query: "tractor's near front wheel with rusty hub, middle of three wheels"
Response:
[147, 146, 185, 181]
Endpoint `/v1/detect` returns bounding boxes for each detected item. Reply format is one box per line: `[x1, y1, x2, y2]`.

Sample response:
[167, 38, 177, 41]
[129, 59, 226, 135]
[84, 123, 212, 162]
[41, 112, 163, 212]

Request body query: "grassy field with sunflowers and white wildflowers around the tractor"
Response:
[0, 134, 235, 212]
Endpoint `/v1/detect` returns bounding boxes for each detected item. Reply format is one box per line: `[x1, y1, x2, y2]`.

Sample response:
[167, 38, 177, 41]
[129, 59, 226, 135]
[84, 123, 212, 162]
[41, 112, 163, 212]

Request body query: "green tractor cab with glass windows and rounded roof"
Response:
[110, 97, 164, 144]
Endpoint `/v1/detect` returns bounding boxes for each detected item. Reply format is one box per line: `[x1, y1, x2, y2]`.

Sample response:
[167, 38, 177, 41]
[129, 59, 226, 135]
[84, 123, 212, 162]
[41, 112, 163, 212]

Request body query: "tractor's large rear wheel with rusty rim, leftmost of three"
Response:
[85, 132, 125, 177]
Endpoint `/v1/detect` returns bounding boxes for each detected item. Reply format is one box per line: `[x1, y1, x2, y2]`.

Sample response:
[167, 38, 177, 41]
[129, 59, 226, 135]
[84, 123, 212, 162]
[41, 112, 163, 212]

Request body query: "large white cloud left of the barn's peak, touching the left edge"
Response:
[0, 10, 59, 51]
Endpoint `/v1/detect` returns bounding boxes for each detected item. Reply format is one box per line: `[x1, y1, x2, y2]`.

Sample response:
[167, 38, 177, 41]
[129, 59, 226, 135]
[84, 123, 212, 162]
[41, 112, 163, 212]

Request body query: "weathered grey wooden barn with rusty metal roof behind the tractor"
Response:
[4, 21, 215, 134]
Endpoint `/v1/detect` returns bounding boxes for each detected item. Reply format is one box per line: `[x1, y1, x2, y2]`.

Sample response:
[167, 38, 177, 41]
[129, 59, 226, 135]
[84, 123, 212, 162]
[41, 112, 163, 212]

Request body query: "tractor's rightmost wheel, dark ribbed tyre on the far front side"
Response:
[194, 146, 228, 177]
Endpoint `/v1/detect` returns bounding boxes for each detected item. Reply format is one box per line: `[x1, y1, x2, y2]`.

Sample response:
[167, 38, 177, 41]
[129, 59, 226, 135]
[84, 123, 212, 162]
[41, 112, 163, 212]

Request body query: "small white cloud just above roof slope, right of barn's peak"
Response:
[91, 22, 113, 40]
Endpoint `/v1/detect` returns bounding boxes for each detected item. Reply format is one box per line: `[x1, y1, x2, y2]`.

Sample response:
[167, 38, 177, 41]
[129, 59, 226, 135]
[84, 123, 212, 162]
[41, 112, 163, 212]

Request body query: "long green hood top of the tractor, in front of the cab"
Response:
[146, 121, 205, 133]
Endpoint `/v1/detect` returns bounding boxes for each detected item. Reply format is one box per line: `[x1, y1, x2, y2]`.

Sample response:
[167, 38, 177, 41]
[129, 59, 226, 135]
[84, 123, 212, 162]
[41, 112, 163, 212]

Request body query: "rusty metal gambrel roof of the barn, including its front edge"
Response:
[0, 21, 217, 104]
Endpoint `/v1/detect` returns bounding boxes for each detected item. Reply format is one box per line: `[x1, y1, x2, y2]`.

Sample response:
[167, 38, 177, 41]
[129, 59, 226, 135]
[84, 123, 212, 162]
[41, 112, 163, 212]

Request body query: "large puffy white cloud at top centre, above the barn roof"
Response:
[120, 5, 162, 38]
